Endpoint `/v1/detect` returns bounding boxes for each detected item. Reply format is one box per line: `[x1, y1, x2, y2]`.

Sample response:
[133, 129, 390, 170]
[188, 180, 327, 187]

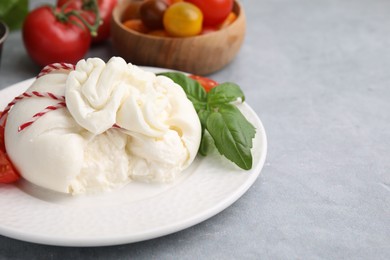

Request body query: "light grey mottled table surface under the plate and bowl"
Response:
[0, 0, 390, 259]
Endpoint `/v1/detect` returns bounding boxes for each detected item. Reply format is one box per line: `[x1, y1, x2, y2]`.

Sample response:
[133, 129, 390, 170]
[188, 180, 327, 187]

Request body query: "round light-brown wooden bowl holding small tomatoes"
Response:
[111, 1, 246, 75]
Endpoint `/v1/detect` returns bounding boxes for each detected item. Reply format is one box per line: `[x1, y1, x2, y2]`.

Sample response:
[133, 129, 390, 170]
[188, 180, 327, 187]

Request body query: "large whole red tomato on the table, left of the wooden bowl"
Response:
[22, 6, 91, 66]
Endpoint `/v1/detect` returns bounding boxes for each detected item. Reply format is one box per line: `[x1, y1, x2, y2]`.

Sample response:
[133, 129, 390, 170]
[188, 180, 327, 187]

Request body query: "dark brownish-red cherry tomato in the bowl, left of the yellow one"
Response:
[139, 0, 168, 30]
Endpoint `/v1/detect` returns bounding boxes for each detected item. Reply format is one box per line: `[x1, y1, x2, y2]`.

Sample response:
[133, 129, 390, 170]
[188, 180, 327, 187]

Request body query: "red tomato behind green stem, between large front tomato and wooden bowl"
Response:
[57, 0, 118, 43]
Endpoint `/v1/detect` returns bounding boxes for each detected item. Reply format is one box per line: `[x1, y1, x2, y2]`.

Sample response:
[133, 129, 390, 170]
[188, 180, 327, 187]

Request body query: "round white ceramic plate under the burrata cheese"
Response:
[0, 68, 267, 246]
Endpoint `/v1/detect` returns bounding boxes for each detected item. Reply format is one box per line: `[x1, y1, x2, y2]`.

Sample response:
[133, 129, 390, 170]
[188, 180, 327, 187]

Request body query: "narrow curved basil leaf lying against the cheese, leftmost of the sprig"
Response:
[157, 72, 207, 112]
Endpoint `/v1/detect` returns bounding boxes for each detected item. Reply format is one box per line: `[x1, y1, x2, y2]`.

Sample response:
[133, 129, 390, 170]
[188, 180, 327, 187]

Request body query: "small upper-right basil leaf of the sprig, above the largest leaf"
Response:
[207, 82, 245, 106]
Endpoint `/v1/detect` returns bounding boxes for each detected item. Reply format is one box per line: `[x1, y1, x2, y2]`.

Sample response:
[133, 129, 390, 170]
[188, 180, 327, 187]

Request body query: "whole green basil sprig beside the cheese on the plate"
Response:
[158, 72, 256, 170]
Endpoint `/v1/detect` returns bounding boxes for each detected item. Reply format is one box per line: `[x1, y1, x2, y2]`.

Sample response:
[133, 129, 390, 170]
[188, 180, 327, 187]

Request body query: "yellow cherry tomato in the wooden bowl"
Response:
[163, 2, 203, 37]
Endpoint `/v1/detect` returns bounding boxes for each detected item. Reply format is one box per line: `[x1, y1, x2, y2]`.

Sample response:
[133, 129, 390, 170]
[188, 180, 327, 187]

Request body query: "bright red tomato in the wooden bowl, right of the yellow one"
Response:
[185, 0, 234, 25]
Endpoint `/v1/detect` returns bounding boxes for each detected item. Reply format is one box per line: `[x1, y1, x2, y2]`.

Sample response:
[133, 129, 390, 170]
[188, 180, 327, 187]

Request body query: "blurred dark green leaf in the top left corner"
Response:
[0, 0, 28, 30]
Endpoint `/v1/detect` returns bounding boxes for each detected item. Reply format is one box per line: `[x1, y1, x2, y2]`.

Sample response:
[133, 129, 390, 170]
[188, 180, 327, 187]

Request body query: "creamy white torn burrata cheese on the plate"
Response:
[5, 57, 201, 194]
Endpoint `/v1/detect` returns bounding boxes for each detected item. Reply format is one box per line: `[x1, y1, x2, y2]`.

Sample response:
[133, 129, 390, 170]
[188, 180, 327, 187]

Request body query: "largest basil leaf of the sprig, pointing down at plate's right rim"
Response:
[206, 104, 256, 170]
